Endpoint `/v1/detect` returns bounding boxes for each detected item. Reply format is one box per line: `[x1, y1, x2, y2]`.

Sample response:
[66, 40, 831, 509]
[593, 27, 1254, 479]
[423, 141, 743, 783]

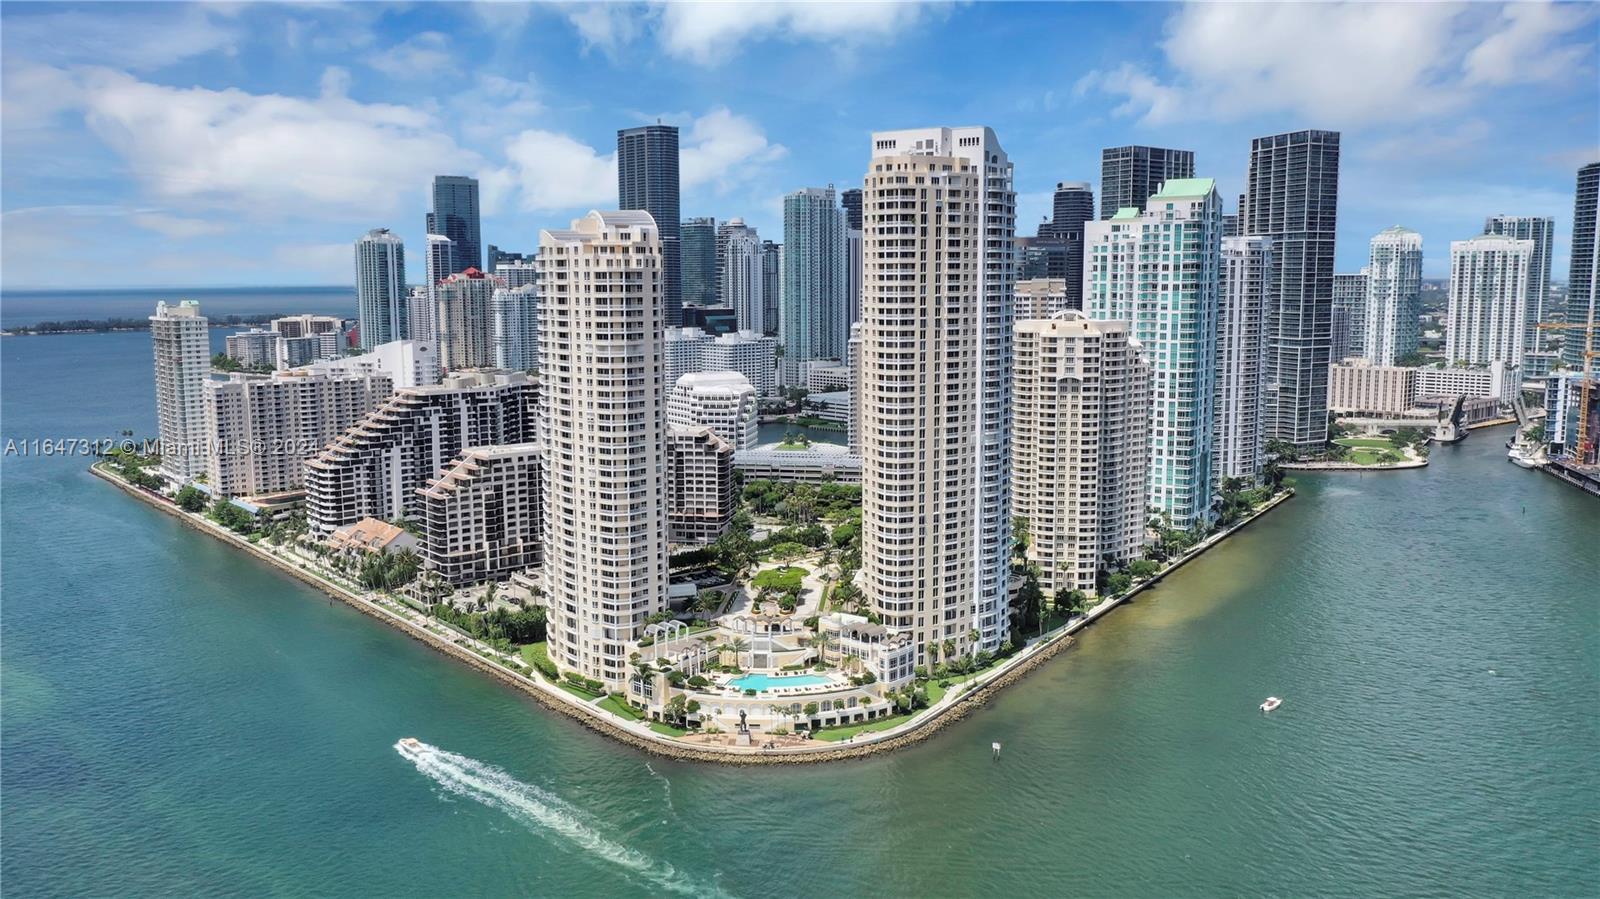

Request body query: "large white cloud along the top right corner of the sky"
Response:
[1077, 3, 1590, 128]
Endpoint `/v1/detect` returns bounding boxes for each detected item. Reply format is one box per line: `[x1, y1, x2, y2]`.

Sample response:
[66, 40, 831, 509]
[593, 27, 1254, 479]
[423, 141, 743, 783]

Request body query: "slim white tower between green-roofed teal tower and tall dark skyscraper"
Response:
[1211, 237, 1277, 488]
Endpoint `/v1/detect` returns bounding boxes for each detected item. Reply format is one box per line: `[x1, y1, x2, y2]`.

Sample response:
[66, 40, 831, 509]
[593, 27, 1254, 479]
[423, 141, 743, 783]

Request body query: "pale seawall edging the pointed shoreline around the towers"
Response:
[90, 465, 1293, 765]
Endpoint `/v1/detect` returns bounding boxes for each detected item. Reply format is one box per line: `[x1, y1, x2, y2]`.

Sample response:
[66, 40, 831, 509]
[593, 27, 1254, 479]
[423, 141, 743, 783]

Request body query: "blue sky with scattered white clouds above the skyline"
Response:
[0, 2, 1600, 288]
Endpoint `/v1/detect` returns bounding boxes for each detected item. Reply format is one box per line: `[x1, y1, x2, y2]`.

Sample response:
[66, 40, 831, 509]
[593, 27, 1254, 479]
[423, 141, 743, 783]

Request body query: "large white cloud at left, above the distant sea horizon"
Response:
[64, 69, 477, 221]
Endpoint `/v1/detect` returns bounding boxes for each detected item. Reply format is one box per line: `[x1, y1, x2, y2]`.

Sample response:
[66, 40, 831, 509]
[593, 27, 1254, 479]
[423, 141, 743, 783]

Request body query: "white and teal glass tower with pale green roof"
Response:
[1083, 178, 1222, 529]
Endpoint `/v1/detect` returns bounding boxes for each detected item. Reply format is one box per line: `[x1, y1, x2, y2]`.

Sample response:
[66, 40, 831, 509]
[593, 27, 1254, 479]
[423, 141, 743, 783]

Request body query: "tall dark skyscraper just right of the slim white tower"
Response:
[1238, 131, 1339, 448]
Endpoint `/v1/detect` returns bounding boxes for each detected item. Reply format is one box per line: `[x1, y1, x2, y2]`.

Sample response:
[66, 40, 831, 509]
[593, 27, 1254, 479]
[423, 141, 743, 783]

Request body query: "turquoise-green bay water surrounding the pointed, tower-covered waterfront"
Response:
[0, 334, 1600, 897]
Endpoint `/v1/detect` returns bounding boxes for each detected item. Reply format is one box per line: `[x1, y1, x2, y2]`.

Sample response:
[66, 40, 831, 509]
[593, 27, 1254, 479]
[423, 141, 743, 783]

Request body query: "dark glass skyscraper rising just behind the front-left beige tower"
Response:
[616, 125, 683, 328]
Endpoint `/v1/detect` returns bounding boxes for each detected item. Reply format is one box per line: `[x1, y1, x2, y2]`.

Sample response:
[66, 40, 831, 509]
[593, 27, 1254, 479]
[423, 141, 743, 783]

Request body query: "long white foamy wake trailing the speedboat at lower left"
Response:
[395, 739, 728, 896]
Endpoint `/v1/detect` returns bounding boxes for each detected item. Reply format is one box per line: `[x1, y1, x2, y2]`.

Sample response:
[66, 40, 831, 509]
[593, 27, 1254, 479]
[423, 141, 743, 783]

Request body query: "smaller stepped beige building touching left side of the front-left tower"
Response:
[416, 443, 544, 585]
